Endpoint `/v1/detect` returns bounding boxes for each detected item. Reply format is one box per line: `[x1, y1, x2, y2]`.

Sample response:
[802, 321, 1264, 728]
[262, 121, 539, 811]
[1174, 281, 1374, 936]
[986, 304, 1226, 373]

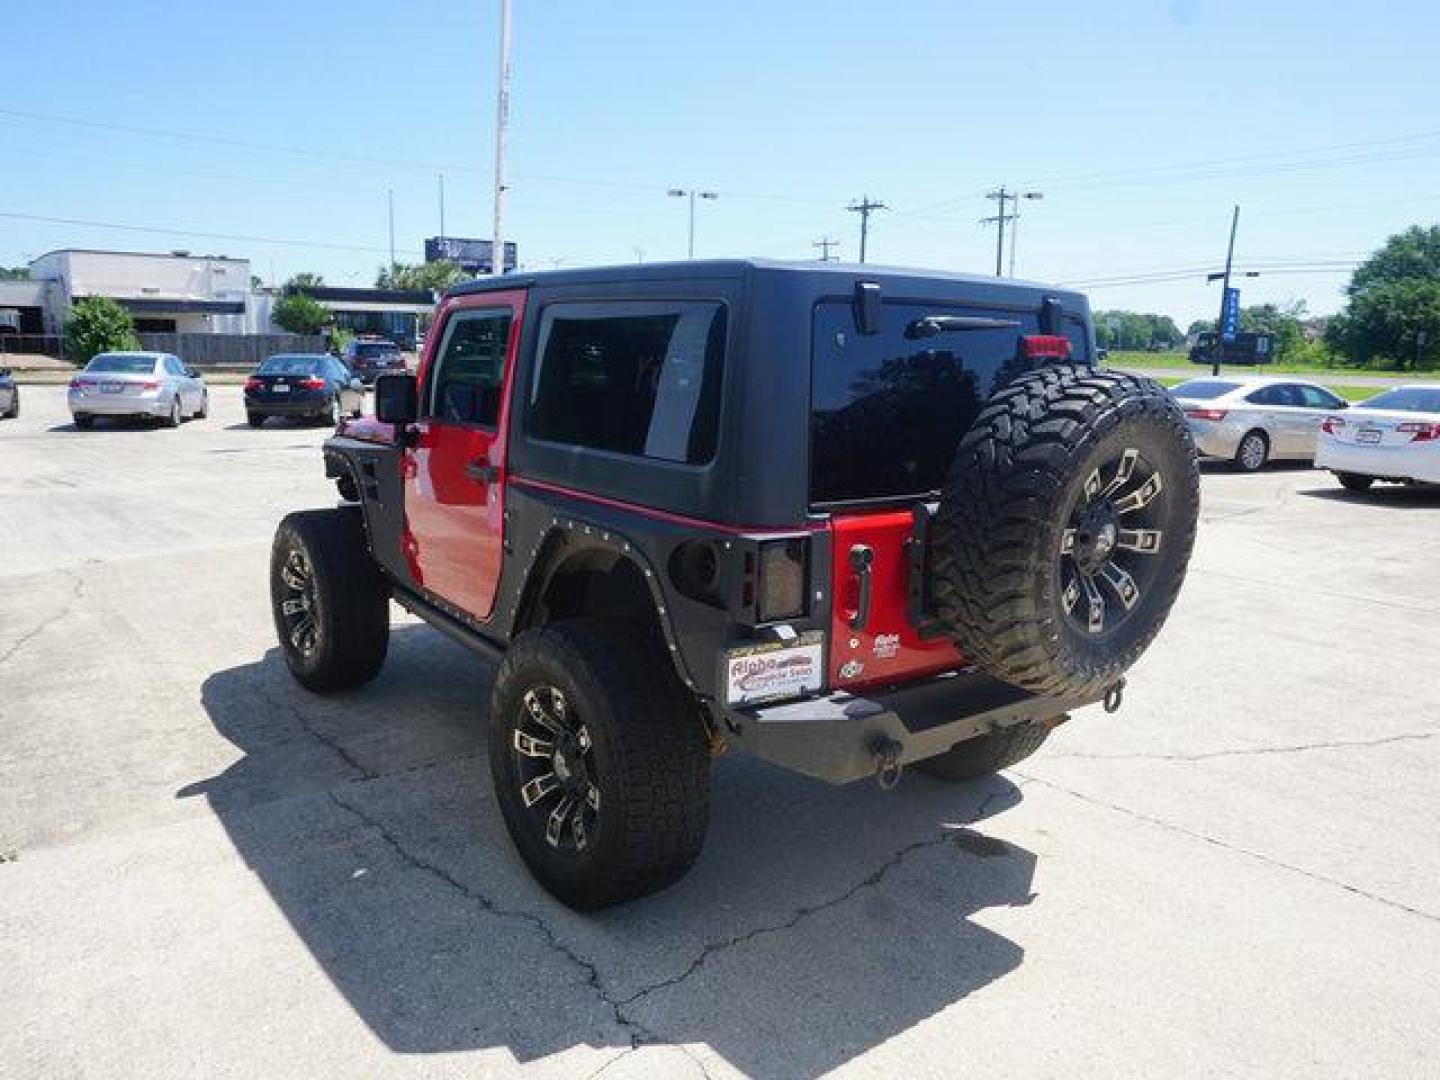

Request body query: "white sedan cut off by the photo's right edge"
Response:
[1315, 384, 1440, 491]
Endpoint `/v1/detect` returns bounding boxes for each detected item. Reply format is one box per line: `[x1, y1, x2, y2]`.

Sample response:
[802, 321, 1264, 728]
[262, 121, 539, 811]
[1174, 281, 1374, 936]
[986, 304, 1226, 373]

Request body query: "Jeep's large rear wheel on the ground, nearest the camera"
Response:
[490, 619, 710, 910]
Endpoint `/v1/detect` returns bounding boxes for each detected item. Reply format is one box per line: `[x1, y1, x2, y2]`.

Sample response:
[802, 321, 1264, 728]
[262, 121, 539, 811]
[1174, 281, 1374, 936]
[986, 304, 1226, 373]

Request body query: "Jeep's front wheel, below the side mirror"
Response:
[271, 510, 390, 693]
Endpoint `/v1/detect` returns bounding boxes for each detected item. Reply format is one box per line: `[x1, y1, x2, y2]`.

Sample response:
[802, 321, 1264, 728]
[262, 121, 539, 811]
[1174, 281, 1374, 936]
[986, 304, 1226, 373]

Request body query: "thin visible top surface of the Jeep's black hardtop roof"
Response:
[445, 258, 1081, 308]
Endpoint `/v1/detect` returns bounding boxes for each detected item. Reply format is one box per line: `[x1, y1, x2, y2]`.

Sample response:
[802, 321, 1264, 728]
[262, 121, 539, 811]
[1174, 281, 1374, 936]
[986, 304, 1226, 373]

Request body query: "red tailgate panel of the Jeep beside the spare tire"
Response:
[829, 510, 965, 688]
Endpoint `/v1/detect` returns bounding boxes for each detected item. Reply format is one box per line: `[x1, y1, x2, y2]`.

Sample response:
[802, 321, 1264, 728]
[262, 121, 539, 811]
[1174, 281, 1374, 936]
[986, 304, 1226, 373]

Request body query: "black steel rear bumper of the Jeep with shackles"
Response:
[724, 671, 1100, 783]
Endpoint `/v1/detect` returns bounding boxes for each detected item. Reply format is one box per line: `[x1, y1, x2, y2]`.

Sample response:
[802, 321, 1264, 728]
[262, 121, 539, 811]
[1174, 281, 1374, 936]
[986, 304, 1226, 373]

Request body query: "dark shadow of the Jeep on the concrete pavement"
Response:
[179, 625, 1035, 1077]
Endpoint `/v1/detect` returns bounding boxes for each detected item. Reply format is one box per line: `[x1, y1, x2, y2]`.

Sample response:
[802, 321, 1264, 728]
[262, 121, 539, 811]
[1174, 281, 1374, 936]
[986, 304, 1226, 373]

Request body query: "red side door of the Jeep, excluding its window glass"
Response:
[402, 289, 526, 619]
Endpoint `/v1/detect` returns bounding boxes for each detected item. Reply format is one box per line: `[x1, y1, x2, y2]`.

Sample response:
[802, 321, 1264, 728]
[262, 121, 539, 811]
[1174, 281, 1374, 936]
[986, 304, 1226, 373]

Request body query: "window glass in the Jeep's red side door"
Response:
[423, 308, 511, 428]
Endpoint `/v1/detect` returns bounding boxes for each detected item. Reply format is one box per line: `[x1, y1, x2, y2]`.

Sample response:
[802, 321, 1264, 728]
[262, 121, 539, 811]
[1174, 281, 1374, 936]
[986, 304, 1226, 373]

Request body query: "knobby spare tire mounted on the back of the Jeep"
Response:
[932, 364, 1200, 697]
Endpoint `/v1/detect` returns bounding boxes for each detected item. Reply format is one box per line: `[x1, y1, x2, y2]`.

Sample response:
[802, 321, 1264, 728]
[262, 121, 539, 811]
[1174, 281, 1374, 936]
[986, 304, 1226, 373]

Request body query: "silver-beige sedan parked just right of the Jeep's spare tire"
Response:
[1171, 374, 1346, 472]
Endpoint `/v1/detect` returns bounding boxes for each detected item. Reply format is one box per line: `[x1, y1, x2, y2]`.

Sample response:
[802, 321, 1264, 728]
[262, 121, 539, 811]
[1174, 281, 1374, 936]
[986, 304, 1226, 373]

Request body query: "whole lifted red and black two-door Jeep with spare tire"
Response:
[271, 261, 1198, 907]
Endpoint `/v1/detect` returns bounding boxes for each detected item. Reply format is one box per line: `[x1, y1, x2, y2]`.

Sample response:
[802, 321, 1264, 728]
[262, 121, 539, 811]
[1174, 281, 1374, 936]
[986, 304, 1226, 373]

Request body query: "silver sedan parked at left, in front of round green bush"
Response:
[69, 353, 210, 428]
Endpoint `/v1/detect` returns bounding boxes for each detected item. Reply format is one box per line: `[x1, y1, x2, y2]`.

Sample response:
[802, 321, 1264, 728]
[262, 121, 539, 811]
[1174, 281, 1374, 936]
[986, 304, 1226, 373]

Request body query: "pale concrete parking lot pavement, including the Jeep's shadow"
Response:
[8, 386, 1440, 1079]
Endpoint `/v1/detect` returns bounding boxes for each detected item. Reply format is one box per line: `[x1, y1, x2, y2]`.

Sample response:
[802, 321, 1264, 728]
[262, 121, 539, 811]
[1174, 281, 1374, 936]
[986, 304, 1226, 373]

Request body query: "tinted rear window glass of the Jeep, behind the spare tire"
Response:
[811, 300, 1090, 505]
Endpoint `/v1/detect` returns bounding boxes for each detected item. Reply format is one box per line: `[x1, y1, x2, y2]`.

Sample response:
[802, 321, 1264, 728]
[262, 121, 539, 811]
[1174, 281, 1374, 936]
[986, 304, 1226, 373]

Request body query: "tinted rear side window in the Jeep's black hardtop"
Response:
[528, 301, 726, 465]
